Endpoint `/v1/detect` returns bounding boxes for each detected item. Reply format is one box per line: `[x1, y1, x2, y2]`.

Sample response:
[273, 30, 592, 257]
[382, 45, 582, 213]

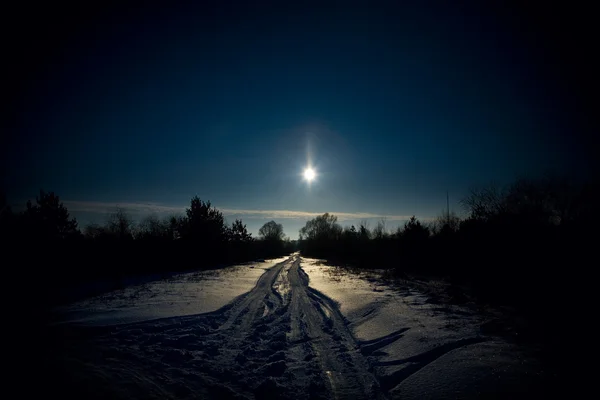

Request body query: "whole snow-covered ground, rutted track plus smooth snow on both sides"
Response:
[49, 254, 543, 399]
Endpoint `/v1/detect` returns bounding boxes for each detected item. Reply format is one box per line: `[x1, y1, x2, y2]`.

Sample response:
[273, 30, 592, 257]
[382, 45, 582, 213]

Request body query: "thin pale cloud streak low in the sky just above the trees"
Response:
[64, 201, 431, 221]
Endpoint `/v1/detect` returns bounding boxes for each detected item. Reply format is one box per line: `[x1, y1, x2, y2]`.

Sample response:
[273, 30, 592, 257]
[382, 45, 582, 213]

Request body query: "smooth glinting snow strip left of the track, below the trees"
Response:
[54, 257, 287, 326]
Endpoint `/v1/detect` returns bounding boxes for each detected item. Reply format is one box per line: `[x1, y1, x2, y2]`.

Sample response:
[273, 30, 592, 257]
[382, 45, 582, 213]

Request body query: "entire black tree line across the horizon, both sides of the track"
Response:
[0, 176, 600, 316]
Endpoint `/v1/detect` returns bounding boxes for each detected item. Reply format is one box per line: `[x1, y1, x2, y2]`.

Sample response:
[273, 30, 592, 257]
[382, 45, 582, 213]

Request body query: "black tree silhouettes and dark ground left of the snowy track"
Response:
[0, 191, 294, 302]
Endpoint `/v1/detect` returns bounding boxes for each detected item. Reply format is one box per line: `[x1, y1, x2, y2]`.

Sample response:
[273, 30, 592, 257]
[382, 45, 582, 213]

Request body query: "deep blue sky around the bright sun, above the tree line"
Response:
[2, 1, 598, 238]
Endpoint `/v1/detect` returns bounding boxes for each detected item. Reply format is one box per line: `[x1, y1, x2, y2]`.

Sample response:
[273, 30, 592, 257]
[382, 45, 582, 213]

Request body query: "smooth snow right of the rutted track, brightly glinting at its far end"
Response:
[302, 258, 544, 399]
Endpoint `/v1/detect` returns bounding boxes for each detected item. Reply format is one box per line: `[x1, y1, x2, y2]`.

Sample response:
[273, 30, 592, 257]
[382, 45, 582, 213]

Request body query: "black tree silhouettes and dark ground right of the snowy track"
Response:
[299, 175, 600, 318]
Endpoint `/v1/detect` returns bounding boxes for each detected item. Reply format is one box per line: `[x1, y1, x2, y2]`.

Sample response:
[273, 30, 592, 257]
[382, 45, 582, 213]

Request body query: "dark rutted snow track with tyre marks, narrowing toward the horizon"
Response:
[50, 255, 482, 399]
